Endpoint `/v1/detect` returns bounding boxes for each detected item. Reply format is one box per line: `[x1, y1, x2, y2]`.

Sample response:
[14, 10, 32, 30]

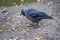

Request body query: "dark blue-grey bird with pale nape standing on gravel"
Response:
[21, 8, 53, 26]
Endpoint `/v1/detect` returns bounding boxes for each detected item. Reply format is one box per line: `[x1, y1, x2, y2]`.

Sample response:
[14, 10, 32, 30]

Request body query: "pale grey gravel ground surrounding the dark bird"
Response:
[0, 3, 60, 40]
